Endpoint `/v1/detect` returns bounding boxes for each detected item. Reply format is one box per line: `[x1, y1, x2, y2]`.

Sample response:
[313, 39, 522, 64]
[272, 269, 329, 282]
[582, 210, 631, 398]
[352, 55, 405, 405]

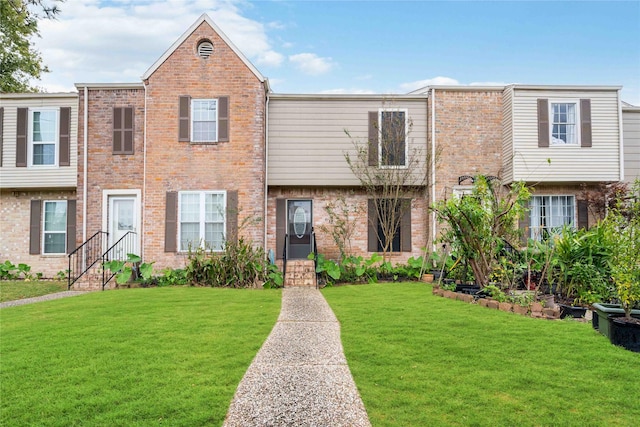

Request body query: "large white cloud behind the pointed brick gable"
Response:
[34, 0, 284, 91]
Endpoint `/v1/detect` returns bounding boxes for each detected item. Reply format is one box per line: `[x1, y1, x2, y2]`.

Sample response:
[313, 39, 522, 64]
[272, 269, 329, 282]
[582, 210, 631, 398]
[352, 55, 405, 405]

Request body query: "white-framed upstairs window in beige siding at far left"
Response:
[29, 109, 58, 166]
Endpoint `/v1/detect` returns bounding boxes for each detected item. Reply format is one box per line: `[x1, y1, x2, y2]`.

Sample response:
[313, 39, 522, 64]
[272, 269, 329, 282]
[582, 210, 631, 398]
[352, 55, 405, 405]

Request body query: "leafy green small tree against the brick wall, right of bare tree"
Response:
[433, 176, 531, 287]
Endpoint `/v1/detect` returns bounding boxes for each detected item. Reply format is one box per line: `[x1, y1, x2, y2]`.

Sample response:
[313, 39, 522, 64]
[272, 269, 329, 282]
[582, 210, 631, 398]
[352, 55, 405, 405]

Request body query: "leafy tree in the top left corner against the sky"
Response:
[0, 0, 63, 92]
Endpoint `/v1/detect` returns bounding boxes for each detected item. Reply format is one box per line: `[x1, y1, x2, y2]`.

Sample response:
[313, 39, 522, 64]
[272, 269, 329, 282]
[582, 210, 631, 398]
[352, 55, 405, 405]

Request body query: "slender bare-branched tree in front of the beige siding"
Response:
[344, 107, 431, 262]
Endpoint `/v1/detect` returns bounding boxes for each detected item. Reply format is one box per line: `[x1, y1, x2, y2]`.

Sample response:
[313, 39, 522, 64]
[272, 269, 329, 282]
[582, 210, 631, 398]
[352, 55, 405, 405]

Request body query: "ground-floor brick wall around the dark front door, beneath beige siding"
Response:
[266, 187, 428, 262]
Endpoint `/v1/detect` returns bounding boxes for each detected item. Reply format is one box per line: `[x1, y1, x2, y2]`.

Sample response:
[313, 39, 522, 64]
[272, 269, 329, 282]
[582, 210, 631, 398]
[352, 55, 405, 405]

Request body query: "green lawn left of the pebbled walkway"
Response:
[0, 288, 281, 426]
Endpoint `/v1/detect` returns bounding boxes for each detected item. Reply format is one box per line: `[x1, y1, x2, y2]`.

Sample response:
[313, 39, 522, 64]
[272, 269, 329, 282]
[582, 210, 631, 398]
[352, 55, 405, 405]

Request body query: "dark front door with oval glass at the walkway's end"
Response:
[287, 200, 313, 259]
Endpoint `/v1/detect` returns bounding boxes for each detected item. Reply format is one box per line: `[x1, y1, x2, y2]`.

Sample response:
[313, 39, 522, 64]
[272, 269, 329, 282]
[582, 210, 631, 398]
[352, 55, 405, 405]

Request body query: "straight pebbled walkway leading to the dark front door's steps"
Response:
[224, 288, 371, 427]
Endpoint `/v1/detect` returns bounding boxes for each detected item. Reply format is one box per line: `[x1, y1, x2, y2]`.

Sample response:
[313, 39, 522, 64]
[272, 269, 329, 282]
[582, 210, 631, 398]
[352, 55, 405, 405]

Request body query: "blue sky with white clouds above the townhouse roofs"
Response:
[34, 0, 640, 105]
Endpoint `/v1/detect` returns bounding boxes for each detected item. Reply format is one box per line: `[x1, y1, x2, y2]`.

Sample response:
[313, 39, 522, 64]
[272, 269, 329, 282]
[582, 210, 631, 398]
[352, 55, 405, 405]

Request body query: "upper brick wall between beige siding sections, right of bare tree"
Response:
[429, 89, 503, 200]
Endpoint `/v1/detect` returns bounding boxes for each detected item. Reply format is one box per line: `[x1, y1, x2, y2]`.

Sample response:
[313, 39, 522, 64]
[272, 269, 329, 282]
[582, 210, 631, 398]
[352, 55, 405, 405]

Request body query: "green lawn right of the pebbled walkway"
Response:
[323, 284, 640, 427]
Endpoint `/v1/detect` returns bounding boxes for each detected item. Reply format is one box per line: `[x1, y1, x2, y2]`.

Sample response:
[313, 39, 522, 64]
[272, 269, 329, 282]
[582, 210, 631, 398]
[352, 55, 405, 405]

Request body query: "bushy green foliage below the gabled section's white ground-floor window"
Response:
[186, 238, 277, 288]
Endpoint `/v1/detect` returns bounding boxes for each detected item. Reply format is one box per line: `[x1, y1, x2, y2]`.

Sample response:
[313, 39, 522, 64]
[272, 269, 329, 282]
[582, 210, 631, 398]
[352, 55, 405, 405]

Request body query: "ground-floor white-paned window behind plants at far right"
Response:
[529, 196, 575, 240]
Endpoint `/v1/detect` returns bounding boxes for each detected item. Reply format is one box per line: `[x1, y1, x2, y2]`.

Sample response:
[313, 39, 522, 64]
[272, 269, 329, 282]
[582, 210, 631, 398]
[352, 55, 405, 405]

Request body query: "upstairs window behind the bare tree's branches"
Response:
[378, 110, 407, 167]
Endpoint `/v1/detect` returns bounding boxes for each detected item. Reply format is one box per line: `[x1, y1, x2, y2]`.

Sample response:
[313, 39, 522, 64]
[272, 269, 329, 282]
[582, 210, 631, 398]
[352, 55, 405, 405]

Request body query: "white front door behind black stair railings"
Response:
[109, 196, 139, 259]
